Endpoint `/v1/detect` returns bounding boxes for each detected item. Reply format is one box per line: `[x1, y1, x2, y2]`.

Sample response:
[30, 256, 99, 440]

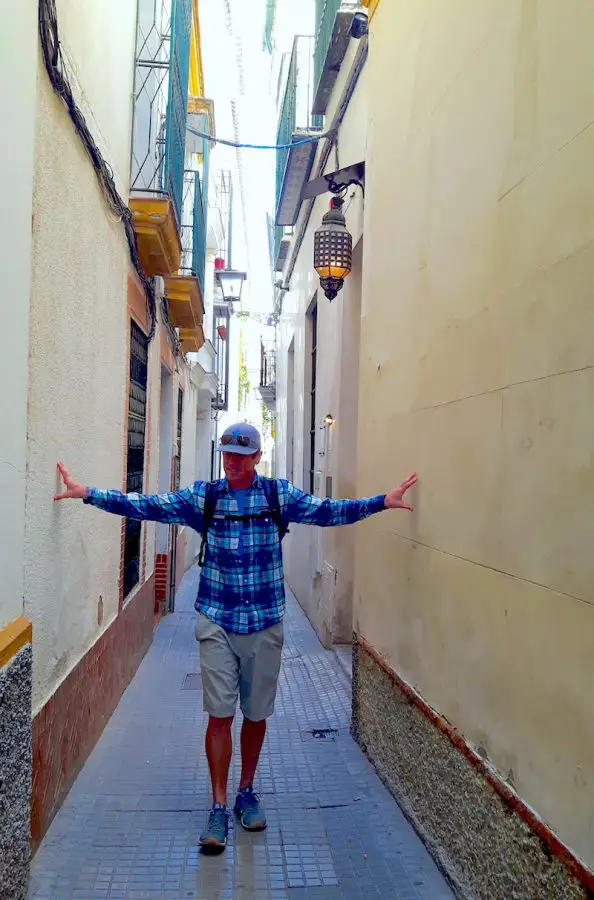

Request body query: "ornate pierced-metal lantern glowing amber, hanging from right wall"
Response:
[314, 197, 353, 300]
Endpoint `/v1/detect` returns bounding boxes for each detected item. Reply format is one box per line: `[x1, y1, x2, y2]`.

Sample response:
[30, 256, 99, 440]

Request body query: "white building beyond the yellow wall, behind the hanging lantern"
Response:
[274, 2, 367, 646]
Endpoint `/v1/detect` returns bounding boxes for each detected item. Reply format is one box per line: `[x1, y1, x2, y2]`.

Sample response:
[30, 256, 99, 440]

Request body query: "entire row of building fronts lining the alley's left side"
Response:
[0, 0, 226, 898]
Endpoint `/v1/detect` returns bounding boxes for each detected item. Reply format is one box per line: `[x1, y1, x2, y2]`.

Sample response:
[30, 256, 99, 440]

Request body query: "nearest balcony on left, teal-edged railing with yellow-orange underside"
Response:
[130, 0, 192, 275]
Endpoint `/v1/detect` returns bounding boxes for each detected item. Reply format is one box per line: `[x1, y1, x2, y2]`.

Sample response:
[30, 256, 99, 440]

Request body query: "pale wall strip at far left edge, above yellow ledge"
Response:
[0, 0, 38, 628]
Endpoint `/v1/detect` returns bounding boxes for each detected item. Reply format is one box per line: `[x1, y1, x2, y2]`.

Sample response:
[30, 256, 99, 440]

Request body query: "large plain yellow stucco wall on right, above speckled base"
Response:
[355, 0, 594, 866]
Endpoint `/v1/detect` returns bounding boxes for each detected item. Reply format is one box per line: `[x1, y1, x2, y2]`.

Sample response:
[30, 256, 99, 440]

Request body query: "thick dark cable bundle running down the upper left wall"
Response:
[39, 0, 161, 342]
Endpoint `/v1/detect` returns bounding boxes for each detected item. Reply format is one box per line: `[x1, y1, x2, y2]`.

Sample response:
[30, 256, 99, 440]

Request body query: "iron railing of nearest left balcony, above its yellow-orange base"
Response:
[130, 0, 192, 222]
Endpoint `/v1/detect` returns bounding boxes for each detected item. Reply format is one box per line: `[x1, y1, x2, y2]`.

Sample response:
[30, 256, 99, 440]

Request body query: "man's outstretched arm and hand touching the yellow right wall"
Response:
[286, 472, 417, 527]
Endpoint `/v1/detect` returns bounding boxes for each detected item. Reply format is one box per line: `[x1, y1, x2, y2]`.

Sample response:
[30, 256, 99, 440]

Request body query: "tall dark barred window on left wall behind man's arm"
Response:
[124, 322, 148, 597]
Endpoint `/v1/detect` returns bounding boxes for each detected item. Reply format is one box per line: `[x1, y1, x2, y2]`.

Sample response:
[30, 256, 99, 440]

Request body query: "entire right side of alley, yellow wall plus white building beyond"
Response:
[276, 0, 594, 900]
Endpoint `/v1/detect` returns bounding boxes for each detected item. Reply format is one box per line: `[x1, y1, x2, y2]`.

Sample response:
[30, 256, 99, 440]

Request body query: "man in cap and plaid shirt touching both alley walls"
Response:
[54, 424, 417, 853]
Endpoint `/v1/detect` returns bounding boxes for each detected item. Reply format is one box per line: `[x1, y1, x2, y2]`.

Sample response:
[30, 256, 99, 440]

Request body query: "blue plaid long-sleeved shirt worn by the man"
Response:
[85, 475, 385, 634]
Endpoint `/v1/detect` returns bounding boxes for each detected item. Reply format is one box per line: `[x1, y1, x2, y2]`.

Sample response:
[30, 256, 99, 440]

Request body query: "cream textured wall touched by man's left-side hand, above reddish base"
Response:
[24, 0, 136, 711]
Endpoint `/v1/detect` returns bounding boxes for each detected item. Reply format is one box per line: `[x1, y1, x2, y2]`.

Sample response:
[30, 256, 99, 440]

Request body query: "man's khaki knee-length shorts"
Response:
[196, 613, 284, 722]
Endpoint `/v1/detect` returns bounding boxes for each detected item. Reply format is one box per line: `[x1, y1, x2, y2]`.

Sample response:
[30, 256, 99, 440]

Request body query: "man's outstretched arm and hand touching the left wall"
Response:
[54, 463, 202, 528]
